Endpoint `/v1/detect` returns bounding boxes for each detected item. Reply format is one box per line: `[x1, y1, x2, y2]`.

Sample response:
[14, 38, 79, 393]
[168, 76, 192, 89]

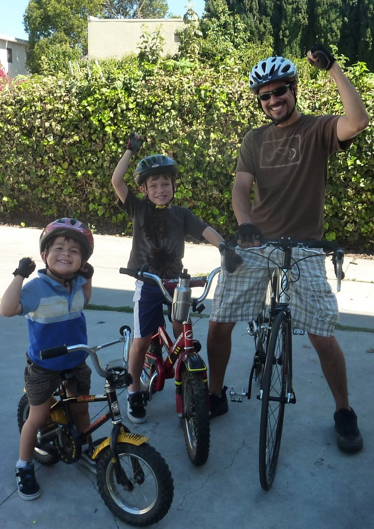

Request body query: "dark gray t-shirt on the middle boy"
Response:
[118, 189, 208, 279]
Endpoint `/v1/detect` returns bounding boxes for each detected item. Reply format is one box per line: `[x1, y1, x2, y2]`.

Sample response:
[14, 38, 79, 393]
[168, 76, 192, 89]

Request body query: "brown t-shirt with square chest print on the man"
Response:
[236, 114, 351, 240]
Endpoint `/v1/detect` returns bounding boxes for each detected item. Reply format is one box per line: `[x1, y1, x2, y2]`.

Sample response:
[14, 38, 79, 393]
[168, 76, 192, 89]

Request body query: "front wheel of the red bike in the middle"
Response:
[182, 370, 210, 466]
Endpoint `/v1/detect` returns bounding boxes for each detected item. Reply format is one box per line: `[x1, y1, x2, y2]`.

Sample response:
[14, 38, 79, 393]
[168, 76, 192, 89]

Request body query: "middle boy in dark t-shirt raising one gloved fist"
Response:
[112, 134, 223, 423]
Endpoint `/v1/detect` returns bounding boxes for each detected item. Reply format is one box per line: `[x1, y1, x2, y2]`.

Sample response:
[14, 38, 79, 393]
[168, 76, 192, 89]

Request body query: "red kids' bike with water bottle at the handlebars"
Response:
[120, 268, 220, 466]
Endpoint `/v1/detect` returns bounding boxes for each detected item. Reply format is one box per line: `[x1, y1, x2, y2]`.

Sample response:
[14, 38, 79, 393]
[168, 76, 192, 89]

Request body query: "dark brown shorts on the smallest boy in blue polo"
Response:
[25, 355, 91, 406]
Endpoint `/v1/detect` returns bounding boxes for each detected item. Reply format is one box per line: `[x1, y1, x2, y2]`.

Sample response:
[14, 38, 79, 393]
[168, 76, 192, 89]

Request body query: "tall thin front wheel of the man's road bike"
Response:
[259, 312, 289, 490]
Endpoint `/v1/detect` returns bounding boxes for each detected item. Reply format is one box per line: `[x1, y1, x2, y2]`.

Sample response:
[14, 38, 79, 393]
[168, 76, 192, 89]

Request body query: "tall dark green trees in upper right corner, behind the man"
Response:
[205, 0, 374, 70]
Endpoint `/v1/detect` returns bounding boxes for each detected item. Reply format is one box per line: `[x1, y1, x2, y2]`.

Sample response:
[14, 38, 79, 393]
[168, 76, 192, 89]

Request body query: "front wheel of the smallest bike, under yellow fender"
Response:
[97, 443, 174, 527]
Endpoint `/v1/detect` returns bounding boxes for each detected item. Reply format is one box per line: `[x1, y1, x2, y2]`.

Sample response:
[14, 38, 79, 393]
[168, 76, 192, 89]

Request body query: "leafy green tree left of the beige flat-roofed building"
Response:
[24, 0, 102, 73]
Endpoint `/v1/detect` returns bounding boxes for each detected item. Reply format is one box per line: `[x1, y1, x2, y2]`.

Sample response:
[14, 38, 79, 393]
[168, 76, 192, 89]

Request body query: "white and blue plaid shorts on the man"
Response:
[210, 248, 339, 336]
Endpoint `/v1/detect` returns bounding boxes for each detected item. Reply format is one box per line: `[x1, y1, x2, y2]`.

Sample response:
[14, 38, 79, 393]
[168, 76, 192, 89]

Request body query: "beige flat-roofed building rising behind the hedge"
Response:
[88, 17, 184, 59]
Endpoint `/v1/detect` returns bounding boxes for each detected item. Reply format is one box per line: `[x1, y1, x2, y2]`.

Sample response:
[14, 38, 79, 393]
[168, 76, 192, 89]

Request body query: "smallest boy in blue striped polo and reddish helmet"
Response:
[0, 218, 94, 500]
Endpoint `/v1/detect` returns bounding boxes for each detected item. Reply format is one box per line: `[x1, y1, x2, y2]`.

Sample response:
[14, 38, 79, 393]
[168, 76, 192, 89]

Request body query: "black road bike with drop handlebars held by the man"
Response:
[226, 238, 344, 490]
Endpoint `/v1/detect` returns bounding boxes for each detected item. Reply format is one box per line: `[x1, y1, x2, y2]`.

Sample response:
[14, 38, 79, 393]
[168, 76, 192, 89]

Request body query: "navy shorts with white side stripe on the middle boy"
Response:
[133, 281, 172, 338]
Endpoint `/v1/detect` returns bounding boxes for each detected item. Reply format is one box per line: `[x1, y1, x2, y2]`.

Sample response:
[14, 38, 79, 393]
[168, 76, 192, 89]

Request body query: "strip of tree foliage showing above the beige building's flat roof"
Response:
[103, 0, 168, 18]
